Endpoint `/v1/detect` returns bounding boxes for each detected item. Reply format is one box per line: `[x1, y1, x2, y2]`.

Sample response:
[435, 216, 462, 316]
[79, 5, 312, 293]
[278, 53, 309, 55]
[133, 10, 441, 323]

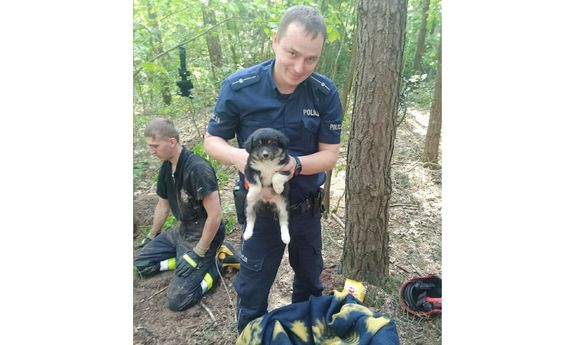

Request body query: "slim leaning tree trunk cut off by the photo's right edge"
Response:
[423, 39, 441, 163]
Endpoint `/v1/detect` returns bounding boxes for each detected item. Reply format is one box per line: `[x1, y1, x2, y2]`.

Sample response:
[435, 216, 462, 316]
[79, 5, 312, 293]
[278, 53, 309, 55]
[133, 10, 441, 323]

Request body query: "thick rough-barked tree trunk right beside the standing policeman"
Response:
[342, 0, 407, 285]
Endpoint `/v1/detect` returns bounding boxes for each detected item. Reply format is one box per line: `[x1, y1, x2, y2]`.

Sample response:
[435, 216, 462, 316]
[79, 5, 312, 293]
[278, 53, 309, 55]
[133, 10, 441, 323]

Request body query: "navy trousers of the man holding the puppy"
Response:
[234, 211, 323, 332]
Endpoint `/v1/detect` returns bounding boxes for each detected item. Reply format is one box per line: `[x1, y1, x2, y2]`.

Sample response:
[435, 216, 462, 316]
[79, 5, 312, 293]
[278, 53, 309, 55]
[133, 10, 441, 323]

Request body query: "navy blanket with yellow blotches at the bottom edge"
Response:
[236, 291, 399, 345]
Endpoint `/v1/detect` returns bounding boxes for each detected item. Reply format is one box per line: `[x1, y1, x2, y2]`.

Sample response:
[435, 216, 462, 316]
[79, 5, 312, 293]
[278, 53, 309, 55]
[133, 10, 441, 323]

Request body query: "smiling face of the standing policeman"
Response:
[273, 23, 323, 93]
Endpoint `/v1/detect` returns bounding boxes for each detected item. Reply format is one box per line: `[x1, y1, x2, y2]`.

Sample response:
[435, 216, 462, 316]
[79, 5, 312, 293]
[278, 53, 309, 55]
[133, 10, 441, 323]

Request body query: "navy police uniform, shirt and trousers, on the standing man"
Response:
[208, 60, 342, 332]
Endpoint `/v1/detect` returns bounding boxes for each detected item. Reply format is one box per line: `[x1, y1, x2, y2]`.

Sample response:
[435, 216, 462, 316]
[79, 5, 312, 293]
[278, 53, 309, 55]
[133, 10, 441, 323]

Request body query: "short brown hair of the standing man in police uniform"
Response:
[278, 5, 326, 42]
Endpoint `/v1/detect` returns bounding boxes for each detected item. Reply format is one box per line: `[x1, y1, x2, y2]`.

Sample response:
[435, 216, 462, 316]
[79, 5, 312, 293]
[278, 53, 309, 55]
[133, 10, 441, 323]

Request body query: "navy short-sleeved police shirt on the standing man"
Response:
[208, 59, 343, 204]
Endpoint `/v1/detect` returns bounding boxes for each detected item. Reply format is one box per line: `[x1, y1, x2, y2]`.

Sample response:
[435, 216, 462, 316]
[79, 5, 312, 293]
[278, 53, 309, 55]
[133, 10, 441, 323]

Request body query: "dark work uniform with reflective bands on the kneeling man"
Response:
[134, 147, 225, 310]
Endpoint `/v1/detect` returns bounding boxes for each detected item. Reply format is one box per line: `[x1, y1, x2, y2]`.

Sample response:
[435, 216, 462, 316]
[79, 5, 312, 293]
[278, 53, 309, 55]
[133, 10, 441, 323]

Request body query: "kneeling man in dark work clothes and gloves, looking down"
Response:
[134, 118, 225, 311]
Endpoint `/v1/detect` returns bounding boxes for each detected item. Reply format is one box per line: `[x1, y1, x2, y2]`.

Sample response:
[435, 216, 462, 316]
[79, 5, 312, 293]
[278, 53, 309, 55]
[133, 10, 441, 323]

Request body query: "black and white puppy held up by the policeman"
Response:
[244, 128, 290, 244]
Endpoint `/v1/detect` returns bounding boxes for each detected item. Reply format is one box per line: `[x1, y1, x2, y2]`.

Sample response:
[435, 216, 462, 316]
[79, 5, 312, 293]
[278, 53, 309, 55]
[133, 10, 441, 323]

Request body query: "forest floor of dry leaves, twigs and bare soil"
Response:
[133, 109, 442, 345]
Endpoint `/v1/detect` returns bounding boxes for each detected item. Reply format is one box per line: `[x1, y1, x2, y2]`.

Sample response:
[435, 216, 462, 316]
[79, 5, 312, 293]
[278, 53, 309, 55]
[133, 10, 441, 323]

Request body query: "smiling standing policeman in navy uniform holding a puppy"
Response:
[204, 6, 342, 332]
